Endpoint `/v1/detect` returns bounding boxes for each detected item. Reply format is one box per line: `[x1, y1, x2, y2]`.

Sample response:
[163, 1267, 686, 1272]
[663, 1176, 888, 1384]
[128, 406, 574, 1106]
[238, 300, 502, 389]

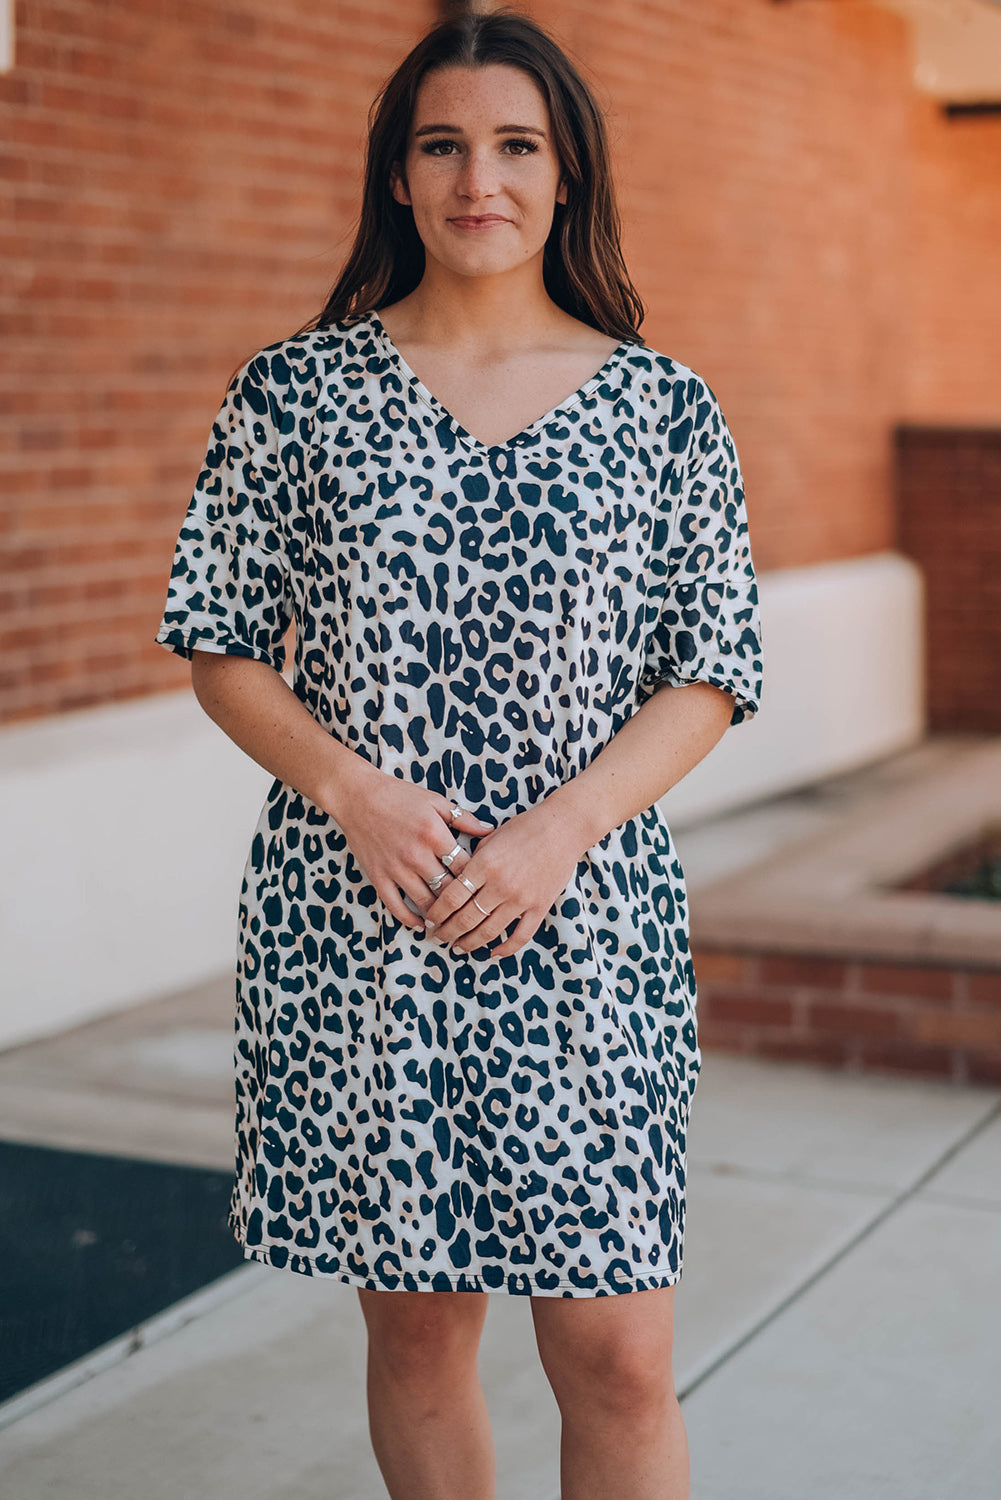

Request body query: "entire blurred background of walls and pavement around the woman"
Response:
[0, 0, 1001, 1500]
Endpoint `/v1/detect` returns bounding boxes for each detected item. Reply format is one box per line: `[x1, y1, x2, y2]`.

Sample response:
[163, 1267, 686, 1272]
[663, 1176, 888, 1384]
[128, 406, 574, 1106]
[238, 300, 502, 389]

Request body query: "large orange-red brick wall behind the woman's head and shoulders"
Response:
[0, 0, 1001, 719]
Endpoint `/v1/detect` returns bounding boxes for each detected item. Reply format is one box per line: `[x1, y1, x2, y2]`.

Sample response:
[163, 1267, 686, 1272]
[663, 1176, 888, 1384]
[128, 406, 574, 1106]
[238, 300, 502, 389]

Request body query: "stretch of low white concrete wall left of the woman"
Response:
[0, 689, 272, 1047]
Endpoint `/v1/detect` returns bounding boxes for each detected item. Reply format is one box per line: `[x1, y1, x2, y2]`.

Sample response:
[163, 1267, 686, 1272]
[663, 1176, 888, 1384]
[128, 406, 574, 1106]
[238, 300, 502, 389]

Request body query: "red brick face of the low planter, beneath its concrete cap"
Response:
[693, 947, 1001, 1083]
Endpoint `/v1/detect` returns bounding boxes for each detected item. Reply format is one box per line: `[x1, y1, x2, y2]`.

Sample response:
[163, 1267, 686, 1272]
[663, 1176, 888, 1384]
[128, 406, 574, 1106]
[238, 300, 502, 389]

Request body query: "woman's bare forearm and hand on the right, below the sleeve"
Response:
[425, 683, 734, 957]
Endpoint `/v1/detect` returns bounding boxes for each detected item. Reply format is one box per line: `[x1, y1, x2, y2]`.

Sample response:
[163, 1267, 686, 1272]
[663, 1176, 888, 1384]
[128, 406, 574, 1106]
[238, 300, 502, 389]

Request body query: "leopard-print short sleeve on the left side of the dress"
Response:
[156, 354, 293, 672]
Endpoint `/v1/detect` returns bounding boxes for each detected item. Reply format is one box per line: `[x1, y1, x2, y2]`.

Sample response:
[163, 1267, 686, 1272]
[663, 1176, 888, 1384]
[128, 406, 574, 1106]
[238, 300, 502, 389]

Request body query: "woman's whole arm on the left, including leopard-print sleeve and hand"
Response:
[156, 351, 491, 927]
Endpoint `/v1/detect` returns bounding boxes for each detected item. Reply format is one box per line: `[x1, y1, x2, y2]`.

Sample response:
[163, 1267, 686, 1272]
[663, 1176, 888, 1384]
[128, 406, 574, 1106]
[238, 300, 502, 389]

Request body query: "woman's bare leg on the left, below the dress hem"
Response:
[359, 1287, 495, 1500]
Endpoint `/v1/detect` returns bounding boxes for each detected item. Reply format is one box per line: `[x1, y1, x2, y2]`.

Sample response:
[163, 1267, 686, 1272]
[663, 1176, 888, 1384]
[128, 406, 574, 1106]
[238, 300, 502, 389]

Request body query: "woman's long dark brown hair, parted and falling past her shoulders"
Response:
[285, 9, 645, 342]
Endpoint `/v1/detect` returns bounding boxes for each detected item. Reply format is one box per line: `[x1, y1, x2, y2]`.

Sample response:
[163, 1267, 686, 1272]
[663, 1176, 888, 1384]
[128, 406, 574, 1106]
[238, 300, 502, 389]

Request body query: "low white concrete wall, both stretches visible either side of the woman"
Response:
[0, 554, 923, 1046]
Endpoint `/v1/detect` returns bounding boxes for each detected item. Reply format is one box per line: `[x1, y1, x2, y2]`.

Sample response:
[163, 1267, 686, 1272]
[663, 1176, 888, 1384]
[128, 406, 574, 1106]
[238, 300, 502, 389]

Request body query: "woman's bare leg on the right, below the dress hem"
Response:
[531, 1287, 689, 1500]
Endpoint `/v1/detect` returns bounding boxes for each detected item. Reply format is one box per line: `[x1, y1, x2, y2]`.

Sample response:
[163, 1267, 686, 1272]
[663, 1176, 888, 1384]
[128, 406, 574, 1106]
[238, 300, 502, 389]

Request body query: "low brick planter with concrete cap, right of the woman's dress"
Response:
[692, 740, 1001, 1083]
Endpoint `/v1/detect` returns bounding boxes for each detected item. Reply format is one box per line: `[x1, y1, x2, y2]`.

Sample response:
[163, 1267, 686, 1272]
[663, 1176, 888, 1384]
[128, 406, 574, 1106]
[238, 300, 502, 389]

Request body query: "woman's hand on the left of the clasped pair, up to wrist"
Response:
[336, 764, 491, 932]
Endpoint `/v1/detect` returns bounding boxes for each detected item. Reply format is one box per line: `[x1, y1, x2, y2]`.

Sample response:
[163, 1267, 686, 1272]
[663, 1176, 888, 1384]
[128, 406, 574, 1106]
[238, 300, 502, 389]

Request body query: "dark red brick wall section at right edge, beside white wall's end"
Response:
[897, 426, 1001, 735]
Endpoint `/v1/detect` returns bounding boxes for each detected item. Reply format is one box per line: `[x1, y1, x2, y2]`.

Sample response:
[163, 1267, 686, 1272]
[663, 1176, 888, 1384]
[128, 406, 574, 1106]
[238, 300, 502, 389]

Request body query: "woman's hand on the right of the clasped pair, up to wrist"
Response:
[425, 797, 590, 959]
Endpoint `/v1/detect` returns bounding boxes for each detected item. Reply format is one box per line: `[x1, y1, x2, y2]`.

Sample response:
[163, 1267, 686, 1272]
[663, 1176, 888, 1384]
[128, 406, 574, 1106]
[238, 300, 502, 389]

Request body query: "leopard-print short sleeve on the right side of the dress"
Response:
[639, 377, 761, 725]
